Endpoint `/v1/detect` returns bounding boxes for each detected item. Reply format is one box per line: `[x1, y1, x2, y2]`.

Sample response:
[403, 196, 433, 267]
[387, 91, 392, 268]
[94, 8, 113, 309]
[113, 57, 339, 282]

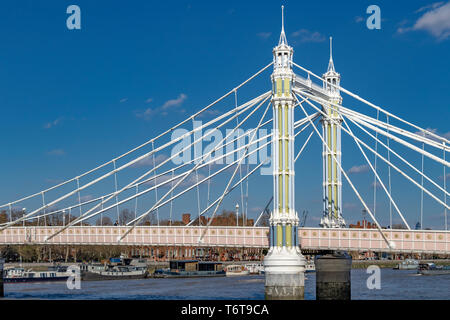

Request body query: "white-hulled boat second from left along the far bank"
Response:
[80, 257, 148, 281]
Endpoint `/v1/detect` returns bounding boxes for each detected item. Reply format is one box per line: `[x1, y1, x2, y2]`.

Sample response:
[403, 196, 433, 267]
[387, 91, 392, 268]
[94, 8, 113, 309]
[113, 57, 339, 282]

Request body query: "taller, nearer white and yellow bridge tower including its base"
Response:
[264, 7, 305, 299]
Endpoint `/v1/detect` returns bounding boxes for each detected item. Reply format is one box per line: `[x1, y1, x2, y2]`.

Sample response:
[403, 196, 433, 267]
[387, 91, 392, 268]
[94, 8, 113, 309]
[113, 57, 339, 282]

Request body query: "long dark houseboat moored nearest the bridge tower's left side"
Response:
[153, 260, 225, 278]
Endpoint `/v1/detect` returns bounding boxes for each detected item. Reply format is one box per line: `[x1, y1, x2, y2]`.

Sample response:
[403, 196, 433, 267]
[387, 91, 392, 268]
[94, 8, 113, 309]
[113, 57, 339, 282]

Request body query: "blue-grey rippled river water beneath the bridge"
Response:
[5, 269, 450, 300]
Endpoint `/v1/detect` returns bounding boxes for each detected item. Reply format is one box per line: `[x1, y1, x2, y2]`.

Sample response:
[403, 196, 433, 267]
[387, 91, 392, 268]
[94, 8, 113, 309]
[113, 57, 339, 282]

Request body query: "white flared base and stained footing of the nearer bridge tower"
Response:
[264, 247, 305, 300]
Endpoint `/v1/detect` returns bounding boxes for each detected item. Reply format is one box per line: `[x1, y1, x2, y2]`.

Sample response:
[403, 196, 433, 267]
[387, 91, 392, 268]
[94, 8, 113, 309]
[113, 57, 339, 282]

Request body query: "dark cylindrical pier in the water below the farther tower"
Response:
[314, 252, 352, 300]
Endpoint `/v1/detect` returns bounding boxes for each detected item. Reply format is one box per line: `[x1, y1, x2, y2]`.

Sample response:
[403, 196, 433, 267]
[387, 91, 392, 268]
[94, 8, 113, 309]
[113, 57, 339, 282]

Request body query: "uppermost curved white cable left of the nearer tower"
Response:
[0, 62, 273, 208]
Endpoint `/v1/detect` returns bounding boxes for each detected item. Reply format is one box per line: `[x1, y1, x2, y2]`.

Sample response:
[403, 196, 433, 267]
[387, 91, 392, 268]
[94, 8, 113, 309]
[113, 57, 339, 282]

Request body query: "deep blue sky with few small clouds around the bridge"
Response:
[0, 0, 450, 227]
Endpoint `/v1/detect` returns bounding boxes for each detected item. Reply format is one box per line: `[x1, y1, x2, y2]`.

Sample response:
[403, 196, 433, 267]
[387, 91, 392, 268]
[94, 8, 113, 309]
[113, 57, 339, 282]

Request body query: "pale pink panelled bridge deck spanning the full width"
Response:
[0, 226, 450, 254]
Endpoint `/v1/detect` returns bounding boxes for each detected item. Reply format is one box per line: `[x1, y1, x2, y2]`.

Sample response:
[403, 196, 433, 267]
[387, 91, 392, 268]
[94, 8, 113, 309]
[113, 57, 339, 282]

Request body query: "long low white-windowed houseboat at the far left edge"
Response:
[3, 266, 70, 283]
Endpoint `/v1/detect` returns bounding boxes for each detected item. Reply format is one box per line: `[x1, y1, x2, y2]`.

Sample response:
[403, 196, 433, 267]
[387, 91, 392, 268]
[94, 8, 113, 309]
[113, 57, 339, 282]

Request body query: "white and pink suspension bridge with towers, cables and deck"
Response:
[0, 8, 450, 258]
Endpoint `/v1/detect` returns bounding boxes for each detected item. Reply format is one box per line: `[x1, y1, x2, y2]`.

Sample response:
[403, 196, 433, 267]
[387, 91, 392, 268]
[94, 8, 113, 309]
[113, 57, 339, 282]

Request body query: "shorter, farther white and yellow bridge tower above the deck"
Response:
[320, 37, 345, 228]
